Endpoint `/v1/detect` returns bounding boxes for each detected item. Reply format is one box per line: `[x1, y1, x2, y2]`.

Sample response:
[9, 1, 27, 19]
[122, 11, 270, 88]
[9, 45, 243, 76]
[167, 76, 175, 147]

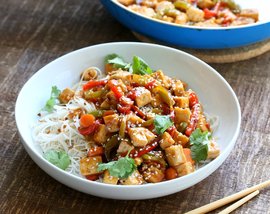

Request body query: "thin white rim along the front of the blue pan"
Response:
[109, 0, 270, 31]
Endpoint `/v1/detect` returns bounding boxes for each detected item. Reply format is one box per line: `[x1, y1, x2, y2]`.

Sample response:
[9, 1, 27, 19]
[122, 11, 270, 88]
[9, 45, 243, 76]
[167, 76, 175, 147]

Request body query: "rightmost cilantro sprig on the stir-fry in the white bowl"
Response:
[189, 128, 212, 162]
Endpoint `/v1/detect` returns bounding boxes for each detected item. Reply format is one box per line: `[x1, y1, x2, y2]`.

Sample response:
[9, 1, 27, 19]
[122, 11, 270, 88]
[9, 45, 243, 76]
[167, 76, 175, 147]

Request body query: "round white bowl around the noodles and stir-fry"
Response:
[15, 42, 241, 200]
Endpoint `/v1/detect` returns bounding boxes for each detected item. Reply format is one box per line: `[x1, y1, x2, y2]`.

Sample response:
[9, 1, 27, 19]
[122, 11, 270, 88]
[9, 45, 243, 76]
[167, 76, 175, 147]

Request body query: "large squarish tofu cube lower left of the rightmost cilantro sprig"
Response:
[165, 145, 186, 166]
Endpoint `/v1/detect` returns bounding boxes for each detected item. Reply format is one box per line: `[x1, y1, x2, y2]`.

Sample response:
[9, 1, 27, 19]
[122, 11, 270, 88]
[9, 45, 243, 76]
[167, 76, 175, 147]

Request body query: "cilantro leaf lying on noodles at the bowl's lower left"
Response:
[44, 150, 71, 170]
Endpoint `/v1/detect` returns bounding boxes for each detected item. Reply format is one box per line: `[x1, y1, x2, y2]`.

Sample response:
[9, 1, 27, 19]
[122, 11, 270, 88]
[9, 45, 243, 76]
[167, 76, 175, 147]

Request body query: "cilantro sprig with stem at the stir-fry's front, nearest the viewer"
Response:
[98, 156, 136, 178]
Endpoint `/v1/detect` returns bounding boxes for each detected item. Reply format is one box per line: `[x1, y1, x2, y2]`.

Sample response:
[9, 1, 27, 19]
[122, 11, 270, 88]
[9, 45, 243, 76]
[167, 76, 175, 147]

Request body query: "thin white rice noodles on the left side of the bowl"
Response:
[33, 96, 96, 176]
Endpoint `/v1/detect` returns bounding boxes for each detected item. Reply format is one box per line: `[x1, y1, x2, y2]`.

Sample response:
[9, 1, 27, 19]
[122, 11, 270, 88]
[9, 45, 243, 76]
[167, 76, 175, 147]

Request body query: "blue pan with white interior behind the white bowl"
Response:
[101, 0, 270, 49]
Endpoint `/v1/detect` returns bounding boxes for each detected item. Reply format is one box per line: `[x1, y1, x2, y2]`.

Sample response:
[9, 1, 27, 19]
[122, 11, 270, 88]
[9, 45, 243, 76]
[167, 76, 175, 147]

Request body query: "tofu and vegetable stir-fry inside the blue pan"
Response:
[118, 0, 259, 27]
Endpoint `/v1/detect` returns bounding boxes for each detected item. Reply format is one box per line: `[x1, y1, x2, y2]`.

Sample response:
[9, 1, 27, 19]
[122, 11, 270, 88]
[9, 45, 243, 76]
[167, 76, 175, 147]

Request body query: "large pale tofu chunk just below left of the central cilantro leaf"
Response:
[128, 127, 156, 147]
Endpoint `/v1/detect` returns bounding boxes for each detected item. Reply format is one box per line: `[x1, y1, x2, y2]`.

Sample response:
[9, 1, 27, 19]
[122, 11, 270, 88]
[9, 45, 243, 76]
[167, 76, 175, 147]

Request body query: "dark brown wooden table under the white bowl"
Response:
[0, 0, 270, 214]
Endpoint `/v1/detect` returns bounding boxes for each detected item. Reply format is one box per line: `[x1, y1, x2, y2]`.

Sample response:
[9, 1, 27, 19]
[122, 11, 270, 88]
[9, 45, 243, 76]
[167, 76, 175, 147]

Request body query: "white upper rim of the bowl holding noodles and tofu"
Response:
[15, 42, 241, 190]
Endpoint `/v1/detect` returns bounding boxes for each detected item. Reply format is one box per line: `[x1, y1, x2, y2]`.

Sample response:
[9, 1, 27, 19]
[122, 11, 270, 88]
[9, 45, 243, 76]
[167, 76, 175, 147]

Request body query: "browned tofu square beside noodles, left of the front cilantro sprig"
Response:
[80, 156, 102, 175]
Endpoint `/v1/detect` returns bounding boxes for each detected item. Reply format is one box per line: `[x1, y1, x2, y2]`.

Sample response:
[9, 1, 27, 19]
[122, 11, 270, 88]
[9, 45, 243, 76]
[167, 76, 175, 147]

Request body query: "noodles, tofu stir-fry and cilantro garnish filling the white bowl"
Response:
[34, 54, 220, 185]
